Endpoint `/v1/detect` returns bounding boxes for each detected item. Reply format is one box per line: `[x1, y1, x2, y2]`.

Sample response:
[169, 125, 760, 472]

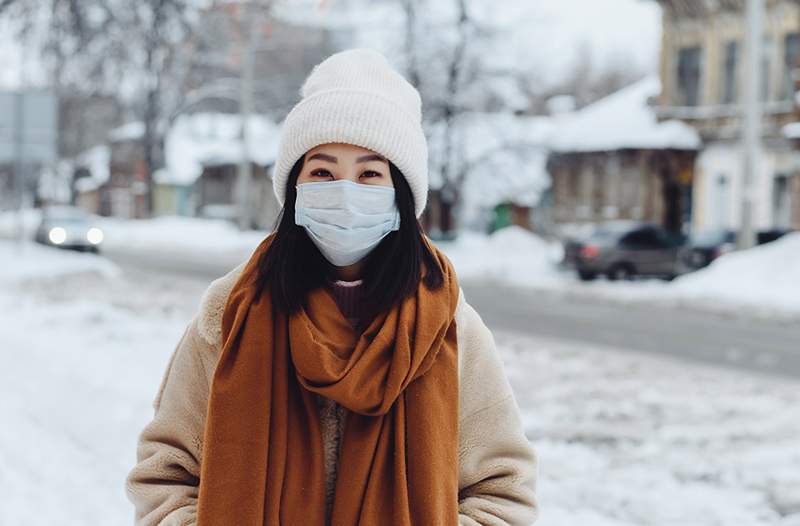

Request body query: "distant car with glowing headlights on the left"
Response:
[35, 206, 103, 254]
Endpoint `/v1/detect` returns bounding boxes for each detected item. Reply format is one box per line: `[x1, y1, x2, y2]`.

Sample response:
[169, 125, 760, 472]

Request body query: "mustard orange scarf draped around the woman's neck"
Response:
[197, 235, 458, 526]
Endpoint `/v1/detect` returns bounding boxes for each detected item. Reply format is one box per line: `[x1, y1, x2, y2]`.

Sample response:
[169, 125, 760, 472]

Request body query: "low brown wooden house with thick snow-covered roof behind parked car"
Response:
[547, 76, 701, 234]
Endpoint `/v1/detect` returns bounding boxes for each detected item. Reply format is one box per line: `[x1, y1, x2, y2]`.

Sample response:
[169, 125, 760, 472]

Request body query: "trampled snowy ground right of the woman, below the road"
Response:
[506, 334, 800, 526]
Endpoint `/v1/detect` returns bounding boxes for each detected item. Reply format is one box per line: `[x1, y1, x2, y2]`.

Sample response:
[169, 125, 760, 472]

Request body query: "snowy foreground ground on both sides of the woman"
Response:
[0, 241, 800, 526]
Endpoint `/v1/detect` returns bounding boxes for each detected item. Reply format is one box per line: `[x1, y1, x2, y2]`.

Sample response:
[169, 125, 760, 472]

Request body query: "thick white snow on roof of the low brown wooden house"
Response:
[550, 75, 701, 152]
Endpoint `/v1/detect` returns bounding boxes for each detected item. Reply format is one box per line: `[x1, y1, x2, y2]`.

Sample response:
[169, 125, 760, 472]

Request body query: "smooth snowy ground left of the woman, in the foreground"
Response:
[0, 241, 202, 526]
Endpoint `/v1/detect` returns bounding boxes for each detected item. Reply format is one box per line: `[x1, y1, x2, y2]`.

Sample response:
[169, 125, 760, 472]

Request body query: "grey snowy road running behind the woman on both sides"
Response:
[105, 248, 800, 378]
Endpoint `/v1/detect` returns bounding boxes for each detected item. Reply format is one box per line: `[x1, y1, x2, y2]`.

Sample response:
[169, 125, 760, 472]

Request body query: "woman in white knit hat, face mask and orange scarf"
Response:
[126, 49, 537, 526]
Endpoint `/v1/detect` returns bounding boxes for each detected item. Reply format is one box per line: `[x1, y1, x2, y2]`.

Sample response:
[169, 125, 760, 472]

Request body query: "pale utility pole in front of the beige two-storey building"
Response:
[737, 0, 764, 249]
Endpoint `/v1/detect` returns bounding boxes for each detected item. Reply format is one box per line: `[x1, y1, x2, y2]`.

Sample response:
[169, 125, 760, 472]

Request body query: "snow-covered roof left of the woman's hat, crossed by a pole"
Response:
[159, 113, 280, 184]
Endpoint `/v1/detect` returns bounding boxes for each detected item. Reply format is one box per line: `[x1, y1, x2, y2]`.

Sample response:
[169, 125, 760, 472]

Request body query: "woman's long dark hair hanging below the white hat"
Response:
[256, 156, 444, 327]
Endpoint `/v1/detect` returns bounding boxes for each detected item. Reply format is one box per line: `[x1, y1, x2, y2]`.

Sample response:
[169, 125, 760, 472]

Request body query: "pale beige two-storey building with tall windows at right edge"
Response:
[654, 0, 800, 230]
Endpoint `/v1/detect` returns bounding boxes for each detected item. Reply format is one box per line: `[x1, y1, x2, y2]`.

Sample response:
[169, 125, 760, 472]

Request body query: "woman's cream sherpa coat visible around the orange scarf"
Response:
[125, 263, 538, 526]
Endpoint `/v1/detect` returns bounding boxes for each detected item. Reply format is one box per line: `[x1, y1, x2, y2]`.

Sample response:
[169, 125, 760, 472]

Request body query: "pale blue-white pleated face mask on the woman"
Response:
[294, 179, 400, 267]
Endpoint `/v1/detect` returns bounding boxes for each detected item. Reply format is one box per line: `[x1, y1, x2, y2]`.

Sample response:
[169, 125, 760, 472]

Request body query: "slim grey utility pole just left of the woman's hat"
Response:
[237, 0, 260, 230]
